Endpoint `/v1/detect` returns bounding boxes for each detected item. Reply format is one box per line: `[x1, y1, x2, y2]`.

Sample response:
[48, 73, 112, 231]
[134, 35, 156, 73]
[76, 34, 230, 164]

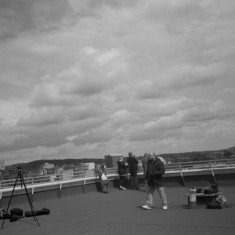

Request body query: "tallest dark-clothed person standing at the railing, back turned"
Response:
[127, 152, 139, 190]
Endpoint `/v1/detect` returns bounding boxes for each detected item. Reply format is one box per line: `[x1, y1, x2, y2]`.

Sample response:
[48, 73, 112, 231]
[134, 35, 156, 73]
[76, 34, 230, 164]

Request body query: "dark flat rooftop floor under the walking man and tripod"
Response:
[0, 186, 235, 235]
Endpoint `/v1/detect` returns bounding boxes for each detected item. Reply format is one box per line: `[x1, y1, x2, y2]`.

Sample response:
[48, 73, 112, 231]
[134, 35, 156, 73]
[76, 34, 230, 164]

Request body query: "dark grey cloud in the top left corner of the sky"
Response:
[0, 0, 72, 39]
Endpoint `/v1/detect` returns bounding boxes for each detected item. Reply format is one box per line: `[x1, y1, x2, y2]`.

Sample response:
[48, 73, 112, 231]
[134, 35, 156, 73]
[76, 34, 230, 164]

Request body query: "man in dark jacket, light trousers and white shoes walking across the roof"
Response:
[142, 153, 167, 210]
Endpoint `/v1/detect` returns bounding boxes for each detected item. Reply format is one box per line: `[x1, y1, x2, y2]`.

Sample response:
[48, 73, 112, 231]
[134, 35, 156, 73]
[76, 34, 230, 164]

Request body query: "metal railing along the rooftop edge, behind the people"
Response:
[0, 158, 235, 189]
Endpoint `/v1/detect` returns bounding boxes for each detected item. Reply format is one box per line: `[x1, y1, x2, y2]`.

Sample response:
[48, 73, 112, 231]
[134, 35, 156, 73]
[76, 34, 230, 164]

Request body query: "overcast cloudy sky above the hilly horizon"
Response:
[0, 0, 235, 165]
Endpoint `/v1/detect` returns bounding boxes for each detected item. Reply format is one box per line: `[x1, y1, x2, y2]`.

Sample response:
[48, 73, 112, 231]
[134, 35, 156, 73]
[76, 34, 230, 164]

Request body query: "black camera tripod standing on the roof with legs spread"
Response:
[1, 166, 39, 229]
